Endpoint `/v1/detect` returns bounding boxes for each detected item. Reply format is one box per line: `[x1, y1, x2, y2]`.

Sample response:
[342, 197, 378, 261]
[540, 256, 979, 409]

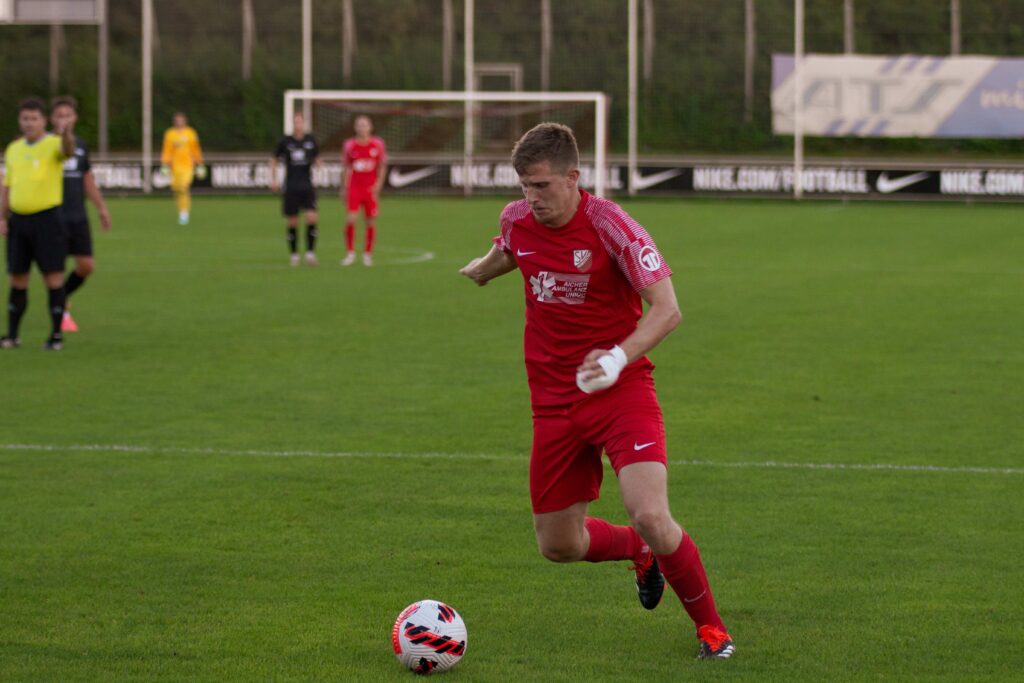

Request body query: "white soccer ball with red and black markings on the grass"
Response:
[391, 600, 466, 676]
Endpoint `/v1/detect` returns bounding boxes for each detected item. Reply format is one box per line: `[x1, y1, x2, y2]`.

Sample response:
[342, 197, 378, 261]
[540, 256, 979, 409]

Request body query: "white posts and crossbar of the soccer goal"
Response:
[284, 89, 609, 197]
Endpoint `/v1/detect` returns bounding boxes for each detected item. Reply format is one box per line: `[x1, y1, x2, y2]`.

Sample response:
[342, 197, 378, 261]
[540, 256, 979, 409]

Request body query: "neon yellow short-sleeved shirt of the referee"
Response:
[3, 134, 65, 214]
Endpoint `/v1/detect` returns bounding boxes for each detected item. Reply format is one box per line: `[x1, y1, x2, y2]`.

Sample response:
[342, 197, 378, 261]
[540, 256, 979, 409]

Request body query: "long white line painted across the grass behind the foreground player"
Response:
[0, 443, 1024, 475]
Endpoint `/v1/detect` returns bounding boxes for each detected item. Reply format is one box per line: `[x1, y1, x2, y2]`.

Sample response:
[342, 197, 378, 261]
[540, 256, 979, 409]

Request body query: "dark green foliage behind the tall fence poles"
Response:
[0, 0, 1024, 156]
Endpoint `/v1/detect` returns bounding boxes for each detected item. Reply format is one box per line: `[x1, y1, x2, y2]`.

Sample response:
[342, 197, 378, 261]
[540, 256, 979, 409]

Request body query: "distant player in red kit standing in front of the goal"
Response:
[341, 116, 387, 265]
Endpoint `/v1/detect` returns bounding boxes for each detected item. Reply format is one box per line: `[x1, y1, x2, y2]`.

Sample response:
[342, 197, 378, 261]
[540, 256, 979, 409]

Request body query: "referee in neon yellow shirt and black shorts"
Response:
[0, 98, 75, 351]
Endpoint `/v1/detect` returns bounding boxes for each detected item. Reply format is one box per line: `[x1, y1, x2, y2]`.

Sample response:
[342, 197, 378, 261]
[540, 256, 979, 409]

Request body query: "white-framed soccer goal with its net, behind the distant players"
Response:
[285, 90, 608, 197]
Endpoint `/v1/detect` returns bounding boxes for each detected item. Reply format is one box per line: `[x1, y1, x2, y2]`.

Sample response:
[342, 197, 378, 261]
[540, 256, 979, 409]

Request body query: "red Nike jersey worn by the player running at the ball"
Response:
[495, 190, 672, 405]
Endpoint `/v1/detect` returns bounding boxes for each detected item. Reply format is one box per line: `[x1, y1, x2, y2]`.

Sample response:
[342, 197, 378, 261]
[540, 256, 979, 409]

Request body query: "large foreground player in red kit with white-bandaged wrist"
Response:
[461, 123, 735, 658]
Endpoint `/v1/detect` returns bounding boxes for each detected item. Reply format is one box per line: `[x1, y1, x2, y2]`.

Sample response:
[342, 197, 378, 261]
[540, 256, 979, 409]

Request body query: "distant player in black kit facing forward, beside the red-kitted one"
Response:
[270, 112, 319, 265]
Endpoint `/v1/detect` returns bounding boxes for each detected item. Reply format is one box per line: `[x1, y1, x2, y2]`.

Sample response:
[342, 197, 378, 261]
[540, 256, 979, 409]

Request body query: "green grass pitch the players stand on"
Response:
[0, 197, 1024, 682]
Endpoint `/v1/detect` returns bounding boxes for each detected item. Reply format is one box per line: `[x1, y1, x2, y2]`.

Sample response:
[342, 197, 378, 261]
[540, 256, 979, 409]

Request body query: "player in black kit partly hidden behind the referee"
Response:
[50, 96, 111, 332]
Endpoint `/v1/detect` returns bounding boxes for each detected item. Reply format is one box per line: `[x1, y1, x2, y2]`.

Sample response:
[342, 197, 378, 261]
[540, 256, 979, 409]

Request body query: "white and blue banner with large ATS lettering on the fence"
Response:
[771, 54, 1024, 137]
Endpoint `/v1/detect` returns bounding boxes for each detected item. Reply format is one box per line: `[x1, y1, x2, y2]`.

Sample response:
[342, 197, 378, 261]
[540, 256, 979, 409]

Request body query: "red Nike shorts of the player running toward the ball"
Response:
[529, 374, 668, 513]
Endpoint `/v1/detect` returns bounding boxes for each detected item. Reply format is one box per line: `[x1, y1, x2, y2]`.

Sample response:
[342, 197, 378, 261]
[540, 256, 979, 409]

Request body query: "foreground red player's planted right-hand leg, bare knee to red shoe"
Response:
[618, 462, 735, 658]
